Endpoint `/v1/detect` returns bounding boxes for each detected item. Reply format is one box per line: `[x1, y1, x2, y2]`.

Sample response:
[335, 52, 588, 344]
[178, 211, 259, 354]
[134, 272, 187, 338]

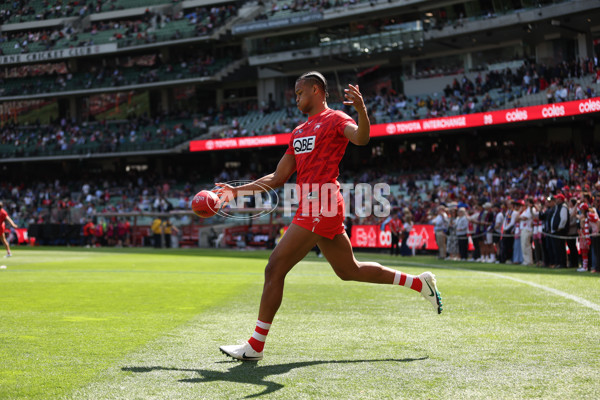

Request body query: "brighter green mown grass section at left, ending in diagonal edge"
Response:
[0, 250, 263, 399]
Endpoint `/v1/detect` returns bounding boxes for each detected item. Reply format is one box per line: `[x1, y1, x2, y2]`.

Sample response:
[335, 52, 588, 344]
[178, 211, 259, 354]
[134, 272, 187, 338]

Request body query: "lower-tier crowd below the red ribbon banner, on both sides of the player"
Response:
[0, 142, 600, 270]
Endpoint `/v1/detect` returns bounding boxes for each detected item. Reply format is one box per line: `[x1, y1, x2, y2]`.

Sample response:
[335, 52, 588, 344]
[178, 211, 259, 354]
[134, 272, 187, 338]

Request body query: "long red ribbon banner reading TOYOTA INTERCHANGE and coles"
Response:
[190, 97, 600, 151]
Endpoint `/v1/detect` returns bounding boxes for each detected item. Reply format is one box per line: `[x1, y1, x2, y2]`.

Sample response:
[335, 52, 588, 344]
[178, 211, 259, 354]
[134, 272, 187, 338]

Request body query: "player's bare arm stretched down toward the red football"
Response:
[216, 154, 296, 199]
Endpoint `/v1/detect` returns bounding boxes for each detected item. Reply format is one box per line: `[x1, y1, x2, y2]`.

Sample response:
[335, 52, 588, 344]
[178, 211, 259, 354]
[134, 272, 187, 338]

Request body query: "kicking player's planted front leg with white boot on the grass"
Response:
[220, 224, 320, 361]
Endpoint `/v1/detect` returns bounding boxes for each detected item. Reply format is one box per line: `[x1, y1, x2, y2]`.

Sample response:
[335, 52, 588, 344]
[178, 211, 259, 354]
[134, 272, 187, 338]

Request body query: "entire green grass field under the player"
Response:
[0, 248, 600, 399]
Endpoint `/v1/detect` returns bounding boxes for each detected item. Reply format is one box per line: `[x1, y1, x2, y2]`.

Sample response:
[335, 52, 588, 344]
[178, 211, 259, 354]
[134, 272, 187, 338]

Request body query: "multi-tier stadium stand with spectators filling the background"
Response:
[0, 0, 600, 260]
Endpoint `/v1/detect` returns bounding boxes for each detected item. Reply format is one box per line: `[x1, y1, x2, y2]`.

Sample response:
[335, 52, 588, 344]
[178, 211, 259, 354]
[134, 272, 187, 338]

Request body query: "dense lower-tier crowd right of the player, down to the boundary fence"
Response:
[342, 148, 600, 272]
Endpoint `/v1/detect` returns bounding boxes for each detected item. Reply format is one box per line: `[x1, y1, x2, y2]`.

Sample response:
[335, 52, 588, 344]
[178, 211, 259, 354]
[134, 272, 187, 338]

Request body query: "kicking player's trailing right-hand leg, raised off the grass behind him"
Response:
[318, 233, 442, 314]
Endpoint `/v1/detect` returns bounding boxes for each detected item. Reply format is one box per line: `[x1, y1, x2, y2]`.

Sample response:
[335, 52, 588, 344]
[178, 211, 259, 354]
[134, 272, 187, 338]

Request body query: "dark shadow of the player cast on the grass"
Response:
[121, 357, 429, 399]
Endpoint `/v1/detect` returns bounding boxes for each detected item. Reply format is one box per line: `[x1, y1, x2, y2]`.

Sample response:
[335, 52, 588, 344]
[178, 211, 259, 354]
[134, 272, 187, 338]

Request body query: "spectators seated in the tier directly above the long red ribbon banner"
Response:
[210, 59, 600, 138]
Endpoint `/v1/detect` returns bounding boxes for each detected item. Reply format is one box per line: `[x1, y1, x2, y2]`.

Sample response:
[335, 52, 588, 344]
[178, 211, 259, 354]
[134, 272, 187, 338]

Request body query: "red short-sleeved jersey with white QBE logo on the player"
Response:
[286, 108, 356, 214]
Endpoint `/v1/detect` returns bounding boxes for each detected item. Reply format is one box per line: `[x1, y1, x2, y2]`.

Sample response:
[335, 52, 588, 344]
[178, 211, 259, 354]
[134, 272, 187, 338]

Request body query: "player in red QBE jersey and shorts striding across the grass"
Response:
[216, 71, 442, 361]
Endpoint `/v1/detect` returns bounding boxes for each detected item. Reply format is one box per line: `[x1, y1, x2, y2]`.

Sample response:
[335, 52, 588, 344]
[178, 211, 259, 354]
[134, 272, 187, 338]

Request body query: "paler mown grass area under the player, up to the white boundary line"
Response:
[67, 255, 598, 400]
